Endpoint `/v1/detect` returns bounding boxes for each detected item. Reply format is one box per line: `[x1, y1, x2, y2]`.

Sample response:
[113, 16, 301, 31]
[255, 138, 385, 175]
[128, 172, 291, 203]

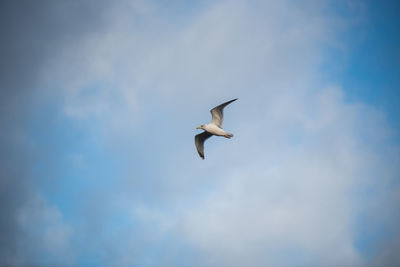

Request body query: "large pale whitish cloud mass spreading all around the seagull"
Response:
[35, 1, 398, 266]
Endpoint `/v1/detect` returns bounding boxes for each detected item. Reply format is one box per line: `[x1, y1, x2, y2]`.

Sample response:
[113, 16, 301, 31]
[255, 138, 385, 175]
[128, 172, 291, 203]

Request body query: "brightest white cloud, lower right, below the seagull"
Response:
[179, 88, 394, 266]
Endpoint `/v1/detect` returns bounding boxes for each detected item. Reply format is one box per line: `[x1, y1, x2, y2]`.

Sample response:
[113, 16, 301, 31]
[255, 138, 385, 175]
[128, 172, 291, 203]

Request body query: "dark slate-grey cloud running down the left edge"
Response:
[0, 0, 111, 265]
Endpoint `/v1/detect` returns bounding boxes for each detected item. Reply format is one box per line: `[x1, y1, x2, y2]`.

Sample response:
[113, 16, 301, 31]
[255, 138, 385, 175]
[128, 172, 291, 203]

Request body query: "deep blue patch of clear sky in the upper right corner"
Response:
[342, 1, 400, 132]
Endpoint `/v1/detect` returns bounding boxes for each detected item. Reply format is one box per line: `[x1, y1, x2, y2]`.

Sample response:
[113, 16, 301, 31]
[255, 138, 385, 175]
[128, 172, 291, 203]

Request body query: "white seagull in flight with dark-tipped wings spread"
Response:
[194, 98, 237, 159]
